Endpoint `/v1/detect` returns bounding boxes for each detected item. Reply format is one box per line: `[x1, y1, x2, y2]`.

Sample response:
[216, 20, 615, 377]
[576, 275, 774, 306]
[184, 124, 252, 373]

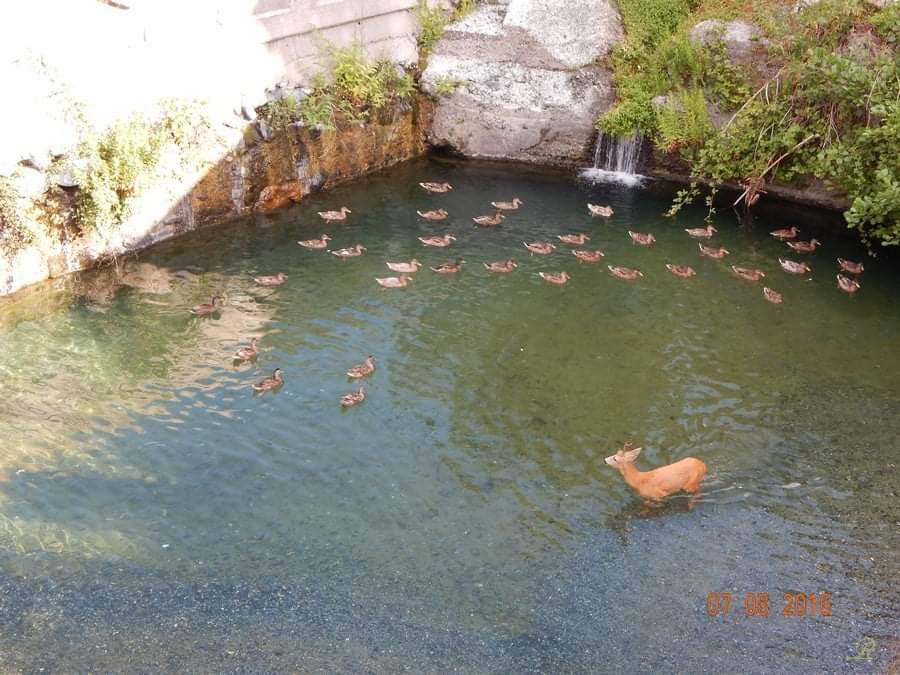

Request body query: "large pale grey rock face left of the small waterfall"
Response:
[423, 0, 623, 165]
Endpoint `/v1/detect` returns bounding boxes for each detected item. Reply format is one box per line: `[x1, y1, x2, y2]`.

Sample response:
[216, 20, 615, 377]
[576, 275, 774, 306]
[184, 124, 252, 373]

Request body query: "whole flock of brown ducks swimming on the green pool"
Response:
[190, 182, 864, 408]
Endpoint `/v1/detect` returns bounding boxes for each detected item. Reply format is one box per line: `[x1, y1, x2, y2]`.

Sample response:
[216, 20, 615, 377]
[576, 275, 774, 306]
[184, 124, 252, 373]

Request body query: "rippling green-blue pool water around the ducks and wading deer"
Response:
[0, 160, 900, 673]
